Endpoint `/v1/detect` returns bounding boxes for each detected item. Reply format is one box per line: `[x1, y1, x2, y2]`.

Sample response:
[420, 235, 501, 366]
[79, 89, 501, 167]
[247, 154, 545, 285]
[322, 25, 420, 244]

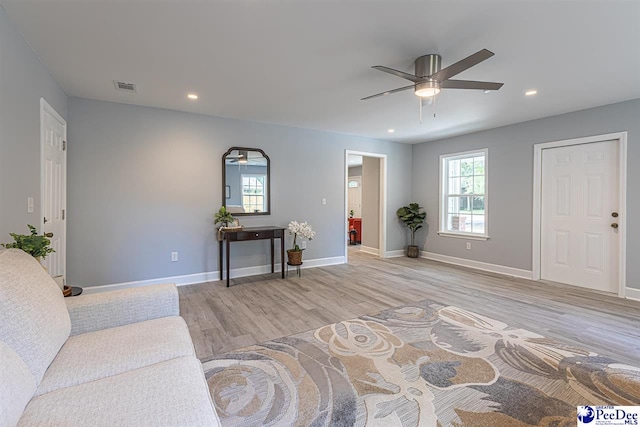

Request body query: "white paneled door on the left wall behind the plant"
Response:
[40, 99, 67, 285]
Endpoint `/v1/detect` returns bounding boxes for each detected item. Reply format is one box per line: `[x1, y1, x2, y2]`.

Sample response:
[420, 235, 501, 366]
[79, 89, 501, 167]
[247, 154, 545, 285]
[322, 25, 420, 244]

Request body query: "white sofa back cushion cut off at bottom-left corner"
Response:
[0, 341, 36, 426]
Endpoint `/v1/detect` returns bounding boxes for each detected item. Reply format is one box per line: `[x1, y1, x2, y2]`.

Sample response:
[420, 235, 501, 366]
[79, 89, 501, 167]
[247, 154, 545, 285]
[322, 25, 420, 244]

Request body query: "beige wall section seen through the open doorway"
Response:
[362, 156, 380, 250]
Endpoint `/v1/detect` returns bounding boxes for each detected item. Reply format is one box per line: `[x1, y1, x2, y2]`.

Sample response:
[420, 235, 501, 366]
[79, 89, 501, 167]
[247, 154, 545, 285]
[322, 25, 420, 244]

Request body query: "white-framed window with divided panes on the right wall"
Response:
[438, 149, 488, 239]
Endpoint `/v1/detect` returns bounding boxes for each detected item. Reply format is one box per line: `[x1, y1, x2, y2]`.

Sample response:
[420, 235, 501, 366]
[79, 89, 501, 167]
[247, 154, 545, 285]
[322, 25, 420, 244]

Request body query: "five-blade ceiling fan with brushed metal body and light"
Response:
[361, 49, 504, 101]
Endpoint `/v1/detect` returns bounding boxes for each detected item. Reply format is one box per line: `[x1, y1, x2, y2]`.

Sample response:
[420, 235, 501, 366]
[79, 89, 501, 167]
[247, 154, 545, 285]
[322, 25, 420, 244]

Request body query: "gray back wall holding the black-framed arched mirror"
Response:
[67, 98, 411, 286]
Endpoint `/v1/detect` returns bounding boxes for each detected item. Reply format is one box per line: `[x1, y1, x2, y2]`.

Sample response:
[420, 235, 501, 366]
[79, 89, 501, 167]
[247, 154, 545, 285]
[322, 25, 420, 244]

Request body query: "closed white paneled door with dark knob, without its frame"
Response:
[540, 141, 619, 292]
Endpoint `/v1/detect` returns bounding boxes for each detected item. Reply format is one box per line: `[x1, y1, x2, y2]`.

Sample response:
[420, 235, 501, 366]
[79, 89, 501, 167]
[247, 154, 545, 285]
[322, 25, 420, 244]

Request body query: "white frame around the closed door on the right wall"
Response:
[532, 132, 627, 298]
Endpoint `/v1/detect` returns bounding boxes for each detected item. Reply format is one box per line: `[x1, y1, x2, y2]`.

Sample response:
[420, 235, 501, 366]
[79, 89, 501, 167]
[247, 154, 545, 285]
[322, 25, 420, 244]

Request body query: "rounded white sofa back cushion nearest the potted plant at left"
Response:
[0, 249, 71, 384]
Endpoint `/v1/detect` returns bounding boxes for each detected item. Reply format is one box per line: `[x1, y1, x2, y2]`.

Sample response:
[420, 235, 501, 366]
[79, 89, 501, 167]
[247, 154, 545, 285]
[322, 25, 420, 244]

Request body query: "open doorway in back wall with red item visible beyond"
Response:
[343, 150, 387, 262]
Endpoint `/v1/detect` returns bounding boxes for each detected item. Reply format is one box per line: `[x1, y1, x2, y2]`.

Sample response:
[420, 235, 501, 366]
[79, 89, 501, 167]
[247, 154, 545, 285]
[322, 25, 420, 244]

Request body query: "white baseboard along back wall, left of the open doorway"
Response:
[83, 256, 345, 294]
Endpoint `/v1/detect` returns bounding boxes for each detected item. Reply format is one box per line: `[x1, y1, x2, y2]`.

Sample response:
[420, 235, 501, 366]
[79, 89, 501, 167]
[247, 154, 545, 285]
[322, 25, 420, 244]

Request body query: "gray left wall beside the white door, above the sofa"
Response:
[0, 7, 67, 239]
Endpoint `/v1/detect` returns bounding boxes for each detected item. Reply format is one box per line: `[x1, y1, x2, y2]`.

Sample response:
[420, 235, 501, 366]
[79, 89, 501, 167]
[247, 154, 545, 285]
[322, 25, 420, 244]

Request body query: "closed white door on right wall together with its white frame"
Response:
[532, 132, 627, 297]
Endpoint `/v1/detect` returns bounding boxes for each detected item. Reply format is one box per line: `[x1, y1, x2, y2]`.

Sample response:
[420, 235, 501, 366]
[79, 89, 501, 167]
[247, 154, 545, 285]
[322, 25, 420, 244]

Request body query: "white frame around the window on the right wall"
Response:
[438, 148, 489, 240]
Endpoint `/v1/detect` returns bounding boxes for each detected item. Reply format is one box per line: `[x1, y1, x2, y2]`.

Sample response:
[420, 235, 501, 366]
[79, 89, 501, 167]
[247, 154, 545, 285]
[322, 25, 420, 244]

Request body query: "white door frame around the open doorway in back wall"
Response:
[342, 150, 387, 262]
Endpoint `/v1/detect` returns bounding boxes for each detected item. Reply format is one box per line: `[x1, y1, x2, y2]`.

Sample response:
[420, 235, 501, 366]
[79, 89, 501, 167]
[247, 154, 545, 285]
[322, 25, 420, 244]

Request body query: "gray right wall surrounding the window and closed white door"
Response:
[412, 99, 640, 288]
